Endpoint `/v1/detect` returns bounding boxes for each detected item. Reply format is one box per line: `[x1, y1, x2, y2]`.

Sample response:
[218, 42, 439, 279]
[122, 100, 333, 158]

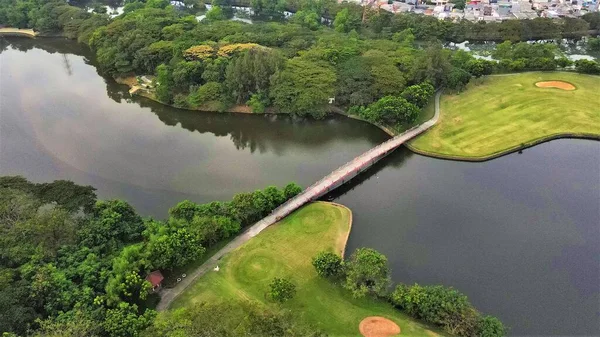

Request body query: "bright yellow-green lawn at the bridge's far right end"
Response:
[409, 72, 600, 160]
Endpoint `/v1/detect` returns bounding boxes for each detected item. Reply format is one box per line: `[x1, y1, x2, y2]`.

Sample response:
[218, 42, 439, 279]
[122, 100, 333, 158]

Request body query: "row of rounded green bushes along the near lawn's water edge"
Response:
[312, 248, 507, 337]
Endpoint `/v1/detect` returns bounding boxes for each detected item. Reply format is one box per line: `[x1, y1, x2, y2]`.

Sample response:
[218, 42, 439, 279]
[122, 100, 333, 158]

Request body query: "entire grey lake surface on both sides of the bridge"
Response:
[0, 39, 600, 336]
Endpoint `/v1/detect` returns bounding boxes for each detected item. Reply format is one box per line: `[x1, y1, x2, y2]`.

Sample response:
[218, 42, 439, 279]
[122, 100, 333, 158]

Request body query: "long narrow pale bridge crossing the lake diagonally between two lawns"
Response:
[156, 91, 441, 311]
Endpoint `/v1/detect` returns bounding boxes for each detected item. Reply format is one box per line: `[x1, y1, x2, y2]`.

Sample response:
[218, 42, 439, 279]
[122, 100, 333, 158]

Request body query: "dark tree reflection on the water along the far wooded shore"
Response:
[5, 38, 386, 156]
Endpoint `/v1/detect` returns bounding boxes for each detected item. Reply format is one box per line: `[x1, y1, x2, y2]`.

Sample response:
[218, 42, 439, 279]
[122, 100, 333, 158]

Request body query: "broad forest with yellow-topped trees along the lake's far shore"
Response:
[0, 0, 600, 130]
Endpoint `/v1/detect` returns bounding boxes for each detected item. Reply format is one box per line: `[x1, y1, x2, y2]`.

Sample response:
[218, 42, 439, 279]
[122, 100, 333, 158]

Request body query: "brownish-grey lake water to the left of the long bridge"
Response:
[0, 39, 386, 217]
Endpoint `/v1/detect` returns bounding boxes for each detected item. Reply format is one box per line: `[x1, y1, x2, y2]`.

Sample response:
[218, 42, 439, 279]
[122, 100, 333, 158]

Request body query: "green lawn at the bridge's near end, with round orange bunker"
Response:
[172, 202, 439, 336]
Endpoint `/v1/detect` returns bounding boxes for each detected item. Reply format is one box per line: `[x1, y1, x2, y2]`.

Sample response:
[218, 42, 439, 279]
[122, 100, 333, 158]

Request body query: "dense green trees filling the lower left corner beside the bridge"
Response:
[0, 176, 301, 337]
